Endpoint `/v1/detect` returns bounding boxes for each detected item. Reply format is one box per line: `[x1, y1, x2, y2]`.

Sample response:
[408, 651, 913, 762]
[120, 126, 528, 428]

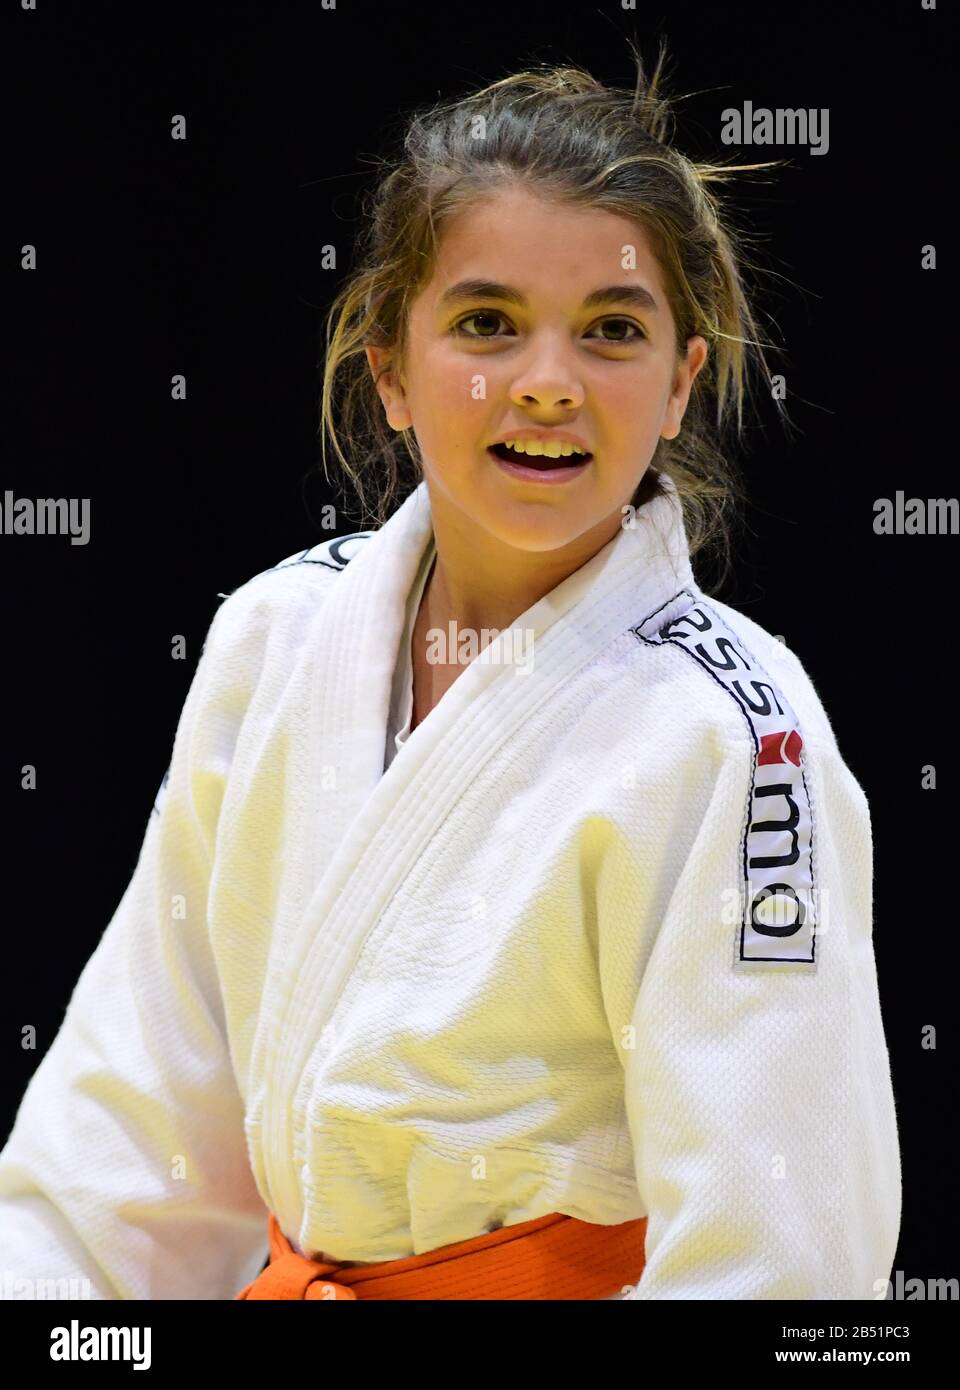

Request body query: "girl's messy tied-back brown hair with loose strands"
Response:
[321, 44, 786, 597]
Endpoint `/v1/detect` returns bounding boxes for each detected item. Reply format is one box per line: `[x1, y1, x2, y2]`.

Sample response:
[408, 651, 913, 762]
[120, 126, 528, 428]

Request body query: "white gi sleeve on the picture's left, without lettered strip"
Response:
[0, 602, 267, 1300]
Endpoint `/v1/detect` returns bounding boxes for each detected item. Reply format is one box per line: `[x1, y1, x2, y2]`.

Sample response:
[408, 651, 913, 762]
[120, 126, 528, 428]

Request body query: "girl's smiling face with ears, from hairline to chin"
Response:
[367, 185, 707, 552]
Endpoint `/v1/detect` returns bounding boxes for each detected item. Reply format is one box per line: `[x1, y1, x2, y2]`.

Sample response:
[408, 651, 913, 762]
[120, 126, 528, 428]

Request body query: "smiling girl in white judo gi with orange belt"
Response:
[0, 48, 900, 1300]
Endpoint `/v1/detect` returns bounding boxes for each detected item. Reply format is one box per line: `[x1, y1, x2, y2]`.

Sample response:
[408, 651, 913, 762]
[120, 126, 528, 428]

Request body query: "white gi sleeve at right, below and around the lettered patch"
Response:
[622, 738, 900, 1300]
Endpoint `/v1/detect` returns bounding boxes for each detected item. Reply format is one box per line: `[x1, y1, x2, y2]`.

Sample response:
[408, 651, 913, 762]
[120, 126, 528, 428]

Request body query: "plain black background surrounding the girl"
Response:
[0, 0, 960, 1279]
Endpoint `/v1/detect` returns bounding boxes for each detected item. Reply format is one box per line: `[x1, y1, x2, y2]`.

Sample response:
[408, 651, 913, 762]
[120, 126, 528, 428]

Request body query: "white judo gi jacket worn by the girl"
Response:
[0, 482, 900, 1300]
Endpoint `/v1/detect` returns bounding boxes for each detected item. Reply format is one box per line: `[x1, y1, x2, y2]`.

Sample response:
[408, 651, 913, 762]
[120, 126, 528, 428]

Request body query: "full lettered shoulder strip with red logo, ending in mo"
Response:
[632, 589, 820, 973]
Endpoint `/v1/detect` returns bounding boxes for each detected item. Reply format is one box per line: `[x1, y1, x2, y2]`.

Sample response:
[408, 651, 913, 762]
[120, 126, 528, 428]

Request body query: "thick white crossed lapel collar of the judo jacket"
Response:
[247, 482, 695, 1230]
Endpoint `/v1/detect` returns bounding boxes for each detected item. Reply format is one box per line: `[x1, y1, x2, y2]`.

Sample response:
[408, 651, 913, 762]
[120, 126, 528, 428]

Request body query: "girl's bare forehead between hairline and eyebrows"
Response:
[424, 186, 663, 303]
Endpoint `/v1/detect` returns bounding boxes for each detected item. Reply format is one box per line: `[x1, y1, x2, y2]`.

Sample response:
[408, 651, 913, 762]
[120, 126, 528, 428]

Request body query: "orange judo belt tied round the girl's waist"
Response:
[236, 1212, 647, 1301]
